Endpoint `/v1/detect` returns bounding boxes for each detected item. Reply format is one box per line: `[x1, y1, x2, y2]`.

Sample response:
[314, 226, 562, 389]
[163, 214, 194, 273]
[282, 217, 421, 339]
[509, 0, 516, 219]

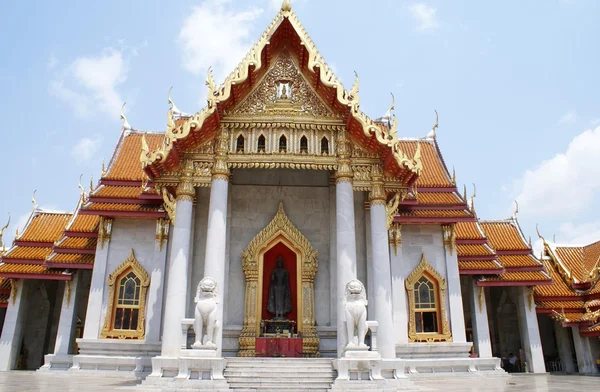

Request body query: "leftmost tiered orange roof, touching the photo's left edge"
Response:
[0, 207, 73, 280]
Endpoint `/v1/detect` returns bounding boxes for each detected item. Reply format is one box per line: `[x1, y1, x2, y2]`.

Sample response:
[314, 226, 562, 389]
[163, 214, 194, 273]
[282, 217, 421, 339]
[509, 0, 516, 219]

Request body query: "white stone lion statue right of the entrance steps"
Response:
[344, 280, 368, 348]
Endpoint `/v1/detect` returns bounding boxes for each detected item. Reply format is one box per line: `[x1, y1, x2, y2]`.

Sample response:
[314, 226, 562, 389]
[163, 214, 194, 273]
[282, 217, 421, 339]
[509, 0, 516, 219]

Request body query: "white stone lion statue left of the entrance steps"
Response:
[192, 277, 219, 348]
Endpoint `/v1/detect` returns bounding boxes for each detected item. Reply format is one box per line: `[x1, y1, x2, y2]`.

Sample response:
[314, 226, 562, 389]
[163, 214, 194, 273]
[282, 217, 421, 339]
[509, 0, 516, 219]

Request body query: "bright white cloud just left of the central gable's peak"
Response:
[179, 0, 263, 83]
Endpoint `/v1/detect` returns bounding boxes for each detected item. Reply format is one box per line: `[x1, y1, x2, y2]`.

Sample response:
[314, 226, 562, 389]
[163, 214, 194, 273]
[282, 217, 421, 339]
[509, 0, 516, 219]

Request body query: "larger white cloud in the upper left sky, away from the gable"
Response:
[49, 48, 127, 118]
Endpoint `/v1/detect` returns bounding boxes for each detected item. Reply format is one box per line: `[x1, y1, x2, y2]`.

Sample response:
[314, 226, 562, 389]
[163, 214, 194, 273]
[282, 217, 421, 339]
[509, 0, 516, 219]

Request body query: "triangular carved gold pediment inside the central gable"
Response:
[225, 52, 337, 118]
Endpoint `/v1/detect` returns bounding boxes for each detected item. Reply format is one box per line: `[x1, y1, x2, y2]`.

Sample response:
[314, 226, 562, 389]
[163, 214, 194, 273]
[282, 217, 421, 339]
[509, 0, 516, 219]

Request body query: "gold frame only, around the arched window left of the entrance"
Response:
[100, 249, 150, 340]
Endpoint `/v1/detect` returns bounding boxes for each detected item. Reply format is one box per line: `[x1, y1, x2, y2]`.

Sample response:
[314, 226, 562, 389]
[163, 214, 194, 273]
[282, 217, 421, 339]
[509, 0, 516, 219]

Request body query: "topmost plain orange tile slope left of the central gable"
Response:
[104, 132, 164, 181]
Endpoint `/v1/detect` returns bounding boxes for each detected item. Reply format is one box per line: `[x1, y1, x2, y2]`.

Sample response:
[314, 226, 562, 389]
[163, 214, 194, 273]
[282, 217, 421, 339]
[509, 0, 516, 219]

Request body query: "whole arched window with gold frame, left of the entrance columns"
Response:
[100, 249, 150, 339]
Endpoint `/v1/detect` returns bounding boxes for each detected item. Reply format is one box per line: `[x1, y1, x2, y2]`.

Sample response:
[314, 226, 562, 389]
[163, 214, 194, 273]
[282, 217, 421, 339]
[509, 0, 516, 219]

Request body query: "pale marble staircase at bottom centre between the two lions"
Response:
[224, 358, 336, 392]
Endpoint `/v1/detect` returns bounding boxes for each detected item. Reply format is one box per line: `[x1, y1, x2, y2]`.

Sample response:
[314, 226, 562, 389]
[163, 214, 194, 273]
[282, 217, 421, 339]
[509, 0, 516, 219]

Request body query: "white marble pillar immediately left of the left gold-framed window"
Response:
[83, 227, 112, 339]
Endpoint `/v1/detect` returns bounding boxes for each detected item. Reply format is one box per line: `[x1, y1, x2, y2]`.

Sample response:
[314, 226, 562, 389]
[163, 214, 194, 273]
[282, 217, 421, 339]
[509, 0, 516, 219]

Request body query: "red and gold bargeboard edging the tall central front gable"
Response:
[138, 2, 423, 185]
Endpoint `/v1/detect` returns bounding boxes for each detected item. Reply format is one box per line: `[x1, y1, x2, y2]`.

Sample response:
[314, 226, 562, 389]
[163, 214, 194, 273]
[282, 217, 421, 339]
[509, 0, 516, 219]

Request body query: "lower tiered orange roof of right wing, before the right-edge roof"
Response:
[477, 216, 552, 286]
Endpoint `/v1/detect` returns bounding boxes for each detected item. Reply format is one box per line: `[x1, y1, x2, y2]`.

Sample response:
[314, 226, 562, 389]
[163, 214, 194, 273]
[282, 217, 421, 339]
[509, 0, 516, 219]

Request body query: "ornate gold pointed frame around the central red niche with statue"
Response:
[238, 203, 319, 357]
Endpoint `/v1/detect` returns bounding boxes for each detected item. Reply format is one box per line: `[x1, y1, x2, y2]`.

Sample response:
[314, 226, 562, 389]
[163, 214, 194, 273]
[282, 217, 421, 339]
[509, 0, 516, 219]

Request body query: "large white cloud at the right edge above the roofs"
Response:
[516, 127, 600, 218]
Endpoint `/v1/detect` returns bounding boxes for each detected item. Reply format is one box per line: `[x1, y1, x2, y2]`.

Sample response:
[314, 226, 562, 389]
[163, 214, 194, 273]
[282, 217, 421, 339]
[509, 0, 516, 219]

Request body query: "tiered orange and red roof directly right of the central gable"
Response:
[394, 136, 477, 224]
